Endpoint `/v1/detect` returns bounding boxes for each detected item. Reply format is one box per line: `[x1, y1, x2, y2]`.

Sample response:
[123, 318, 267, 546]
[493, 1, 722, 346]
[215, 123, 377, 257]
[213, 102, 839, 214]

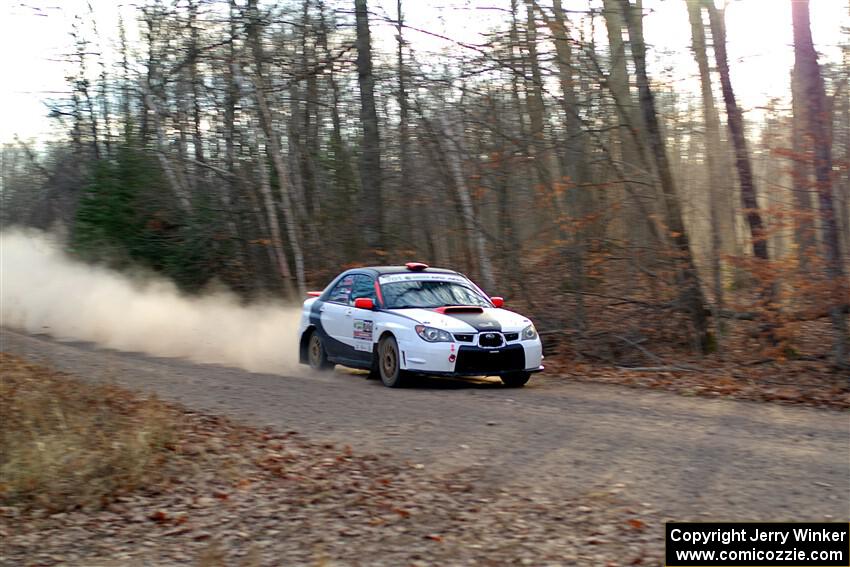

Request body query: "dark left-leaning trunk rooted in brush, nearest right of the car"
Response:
[620, 0, 710, 350]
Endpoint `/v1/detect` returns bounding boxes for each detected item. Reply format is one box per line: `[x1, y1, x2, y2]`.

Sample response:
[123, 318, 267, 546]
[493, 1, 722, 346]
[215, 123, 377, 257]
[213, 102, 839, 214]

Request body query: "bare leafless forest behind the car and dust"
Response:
[0, 0, 850, 374]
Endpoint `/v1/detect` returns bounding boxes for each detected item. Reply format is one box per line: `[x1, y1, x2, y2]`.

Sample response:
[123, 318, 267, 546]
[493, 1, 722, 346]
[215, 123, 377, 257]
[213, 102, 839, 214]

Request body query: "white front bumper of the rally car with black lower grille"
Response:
[399, 337, 543, 376]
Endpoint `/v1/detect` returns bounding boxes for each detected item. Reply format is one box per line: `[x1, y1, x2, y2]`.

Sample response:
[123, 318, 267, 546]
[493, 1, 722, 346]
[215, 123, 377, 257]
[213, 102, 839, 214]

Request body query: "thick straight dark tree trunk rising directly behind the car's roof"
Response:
[354, 0, 384, 255]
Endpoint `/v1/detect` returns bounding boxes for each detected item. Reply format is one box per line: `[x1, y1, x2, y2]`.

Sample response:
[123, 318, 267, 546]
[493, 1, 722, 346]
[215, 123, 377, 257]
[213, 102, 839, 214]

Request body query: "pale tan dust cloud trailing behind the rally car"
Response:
[0, 231, 300, 373]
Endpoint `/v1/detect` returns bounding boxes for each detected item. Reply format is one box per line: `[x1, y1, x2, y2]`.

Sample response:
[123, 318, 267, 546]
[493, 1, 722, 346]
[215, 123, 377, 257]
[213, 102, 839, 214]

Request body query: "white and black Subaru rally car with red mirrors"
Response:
[298, 262, 543, 388]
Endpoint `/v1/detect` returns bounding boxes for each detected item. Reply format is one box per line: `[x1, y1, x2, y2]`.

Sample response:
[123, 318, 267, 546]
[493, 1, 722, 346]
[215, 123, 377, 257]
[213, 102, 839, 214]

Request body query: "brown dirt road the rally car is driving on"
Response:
[0, 329, 850, 520]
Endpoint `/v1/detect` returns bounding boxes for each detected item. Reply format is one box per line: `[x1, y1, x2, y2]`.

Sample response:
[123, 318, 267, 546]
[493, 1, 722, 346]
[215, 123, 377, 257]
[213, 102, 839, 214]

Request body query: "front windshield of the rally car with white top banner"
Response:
[381, 280, 490, 309]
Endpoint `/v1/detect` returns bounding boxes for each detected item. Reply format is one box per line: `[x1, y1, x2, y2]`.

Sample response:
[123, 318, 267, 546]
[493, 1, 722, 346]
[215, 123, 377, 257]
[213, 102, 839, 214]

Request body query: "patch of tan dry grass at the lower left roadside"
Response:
[0, 353, 177, 511]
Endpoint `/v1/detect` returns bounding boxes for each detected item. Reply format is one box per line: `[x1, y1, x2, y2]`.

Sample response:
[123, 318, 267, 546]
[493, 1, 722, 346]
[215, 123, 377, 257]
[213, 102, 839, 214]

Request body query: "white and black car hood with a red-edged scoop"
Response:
[388, 307, 531, 333]
